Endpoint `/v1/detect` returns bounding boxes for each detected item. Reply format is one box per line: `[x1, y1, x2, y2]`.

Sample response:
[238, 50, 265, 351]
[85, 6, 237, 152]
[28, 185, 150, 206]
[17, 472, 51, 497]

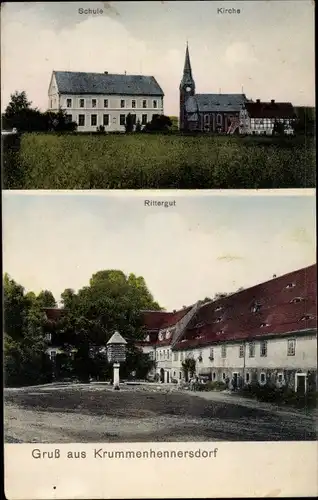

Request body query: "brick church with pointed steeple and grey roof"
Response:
[179, 44, 249, 134]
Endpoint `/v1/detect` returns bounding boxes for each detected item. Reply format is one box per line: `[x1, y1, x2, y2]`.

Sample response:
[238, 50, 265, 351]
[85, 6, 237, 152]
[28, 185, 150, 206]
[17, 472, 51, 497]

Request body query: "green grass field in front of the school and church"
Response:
[4, 133, 315, 189]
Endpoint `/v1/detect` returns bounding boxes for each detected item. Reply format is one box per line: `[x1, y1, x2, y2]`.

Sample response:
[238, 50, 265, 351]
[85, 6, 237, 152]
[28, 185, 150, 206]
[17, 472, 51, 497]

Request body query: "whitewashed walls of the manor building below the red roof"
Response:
[143, 332, 317, 387]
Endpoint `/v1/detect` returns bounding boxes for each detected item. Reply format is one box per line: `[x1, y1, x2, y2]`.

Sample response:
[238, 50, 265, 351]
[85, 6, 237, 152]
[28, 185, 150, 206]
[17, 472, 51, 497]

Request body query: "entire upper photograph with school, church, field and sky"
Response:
[1, 0, 316, 190]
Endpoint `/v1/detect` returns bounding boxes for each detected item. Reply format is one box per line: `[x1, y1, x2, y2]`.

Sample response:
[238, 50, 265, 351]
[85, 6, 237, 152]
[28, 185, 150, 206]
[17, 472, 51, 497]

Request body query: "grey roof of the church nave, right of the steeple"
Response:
[186, 94, 249, 113]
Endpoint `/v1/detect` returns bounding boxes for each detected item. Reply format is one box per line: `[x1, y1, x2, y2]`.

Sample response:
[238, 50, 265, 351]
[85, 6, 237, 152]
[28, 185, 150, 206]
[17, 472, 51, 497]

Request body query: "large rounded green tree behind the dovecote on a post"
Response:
[55, 269, 160, 381]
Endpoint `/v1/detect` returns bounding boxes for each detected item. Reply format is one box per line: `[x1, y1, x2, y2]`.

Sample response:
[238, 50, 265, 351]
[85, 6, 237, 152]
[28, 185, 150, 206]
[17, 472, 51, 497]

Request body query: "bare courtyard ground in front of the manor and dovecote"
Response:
[4, 384, 317, 443]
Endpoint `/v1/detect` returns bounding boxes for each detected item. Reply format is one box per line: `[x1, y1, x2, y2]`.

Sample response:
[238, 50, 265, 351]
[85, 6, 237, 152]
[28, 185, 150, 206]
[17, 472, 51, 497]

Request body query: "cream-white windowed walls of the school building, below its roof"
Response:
[49, 76, 163, 132]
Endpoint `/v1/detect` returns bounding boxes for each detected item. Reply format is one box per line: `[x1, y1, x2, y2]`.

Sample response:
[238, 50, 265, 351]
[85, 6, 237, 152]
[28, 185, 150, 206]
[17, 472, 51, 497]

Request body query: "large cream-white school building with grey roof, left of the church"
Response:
[48, 71, 164, 132]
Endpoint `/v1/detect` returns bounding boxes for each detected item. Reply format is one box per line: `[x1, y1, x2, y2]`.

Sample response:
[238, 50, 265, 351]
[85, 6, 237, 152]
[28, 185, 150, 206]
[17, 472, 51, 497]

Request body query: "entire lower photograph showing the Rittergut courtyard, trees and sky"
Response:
[3, 190, 318, 444]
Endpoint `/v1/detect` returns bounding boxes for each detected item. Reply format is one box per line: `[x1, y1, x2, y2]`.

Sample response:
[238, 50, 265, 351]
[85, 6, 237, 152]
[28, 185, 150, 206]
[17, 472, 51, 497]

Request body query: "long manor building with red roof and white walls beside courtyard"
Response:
[45, 264, 317, 393]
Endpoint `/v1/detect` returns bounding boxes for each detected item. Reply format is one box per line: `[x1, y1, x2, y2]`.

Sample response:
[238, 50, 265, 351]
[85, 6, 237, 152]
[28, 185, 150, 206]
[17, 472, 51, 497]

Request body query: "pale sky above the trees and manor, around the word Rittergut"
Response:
[2, 190, 316, 310]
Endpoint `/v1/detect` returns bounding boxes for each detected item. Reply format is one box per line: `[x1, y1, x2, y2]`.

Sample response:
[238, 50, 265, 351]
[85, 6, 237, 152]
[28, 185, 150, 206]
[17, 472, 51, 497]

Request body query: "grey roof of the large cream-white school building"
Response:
[53, 71, 164, 96]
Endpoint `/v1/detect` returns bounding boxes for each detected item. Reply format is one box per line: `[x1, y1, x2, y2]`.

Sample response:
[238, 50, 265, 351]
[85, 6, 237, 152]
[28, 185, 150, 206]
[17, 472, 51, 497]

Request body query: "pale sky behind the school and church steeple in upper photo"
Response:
[1, 0, 315, 116]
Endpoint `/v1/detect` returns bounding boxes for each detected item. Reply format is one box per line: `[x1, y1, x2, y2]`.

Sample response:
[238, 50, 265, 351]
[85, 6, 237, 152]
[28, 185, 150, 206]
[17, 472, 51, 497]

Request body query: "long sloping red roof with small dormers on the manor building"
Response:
[175, 265, 317, 349]
